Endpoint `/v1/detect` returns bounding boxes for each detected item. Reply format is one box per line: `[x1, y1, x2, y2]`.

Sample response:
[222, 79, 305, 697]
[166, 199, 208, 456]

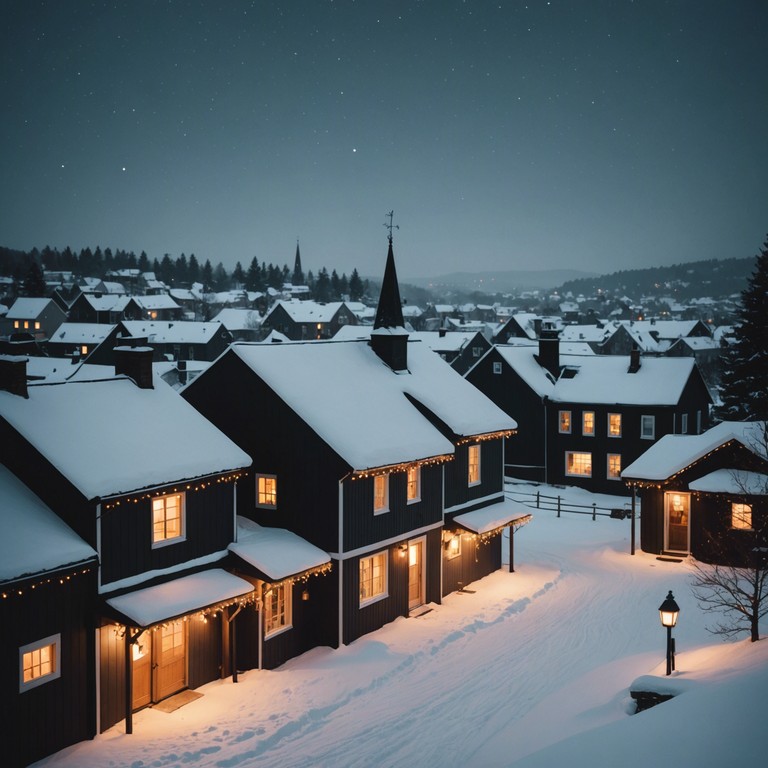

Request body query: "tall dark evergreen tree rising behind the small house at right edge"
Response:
[720, 238, 768, 421]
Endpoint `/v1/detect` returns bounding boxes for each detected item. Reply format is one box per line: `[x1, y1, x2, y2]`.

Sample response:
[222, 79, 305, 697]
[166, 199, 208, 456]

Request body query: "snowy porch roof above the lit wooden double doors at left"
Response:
[107, 568, 253, 629]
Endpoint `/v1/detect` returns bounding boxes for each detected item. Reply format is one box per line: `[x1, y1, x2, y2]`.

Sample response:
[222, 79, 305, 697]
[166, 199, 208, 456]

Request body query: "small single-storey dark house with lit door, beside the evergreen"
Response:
[622, 422, 768, 566]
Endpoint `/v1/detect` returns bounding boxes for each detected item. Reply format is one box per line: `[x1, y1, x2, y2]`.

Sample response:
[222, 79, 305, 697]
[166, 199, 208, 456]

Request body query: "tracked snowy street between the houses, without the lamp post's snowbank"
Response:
[44, 513, 710, 768]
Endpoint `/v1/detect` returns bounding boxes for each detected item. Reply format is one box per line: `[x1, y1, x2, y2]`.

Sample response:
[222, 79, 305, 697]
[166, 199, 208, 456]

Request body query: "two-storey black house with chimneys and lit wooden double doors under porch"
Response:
[0, 354, 255, 744]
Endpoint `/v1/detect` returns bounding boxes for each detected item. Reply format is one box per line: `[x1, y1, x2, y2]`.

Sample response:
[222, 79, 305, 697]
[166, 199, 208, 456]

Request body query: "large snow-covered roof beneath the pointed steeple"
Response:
[226, 341, 517, 470]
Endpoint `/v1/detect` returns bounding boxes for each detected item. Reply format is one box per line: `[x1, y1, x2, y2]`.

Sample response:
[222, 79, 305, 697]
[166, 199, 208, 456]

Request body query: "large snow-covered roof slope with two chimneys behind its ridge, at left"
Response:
[0, 377, 251, 499]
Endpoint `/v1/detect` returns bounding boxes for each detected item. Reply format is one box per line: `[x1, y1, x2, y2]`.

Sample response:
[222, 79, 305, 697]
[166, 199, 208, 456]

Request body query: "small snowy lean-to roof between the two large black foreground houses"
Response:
[229, 515, 331, 581]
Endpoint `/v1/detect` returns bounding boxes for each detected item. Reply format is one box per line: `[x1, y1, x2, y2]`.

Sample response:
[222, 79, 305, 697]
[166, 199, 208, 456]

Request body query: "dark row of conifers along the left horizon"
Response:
[0, 246, 368, 301]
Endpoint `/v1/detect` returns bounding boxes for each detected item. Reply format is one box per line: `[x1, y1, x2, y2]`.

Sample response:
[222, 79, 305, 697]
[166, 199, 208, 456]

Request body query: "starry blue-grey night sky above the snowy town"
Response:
[0, 0, 768, 278]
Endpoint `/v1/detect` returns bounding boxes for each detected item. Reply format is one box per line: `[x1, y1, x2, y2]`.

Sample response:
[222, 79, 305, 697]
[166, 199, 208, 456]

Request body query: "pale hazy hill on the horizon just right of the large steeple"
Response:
[403, 269, 598, 294]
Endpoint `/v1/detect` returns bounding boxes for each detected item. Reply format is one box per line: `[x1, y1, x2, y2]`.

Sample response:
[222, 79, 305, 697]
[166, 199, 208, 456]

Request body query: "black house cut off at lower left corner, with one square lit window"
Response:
[0, 465, 98, 768]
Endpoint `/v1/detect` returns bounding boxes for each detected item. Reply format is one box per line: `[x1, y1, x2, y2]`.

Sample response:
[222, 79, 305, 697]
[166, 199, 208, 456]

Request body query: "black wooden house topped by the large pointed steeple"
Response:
[182, 236, 519, 665]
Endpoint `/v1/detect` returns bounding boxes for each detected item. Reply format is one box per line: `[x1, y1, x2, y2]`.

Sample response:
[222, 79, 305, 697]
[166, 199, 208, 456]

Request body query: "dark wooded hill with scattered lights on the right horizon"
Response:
[559, 256, 755, 299]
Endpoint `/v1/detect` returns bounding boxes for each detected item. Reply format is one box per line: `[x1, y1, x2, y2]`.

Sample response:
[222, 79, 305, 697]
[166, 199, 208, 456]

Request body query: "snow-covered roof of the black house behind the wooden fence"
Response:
[496, 344, 695, 405]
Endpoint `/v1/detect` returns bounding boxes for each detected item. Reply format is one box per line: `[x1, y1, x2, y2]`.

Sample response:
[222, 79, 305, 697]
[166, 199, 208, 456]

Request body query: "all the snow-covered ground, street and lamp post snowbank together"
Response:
[38, 489, 768, 768]
